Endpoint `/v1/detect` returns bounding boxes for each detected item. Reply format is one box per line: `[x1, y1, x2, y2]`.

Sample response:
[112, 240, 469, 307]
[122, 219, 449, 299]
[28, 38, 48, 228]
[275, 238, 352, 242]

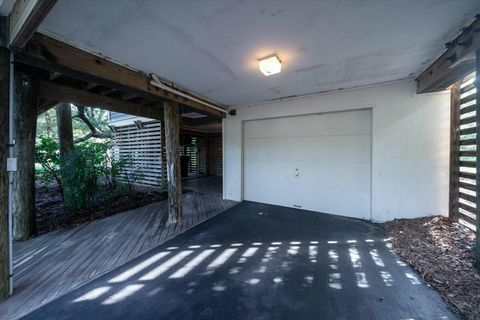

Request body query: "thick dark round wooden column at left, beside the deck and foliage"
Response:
[13, 72, 38, 240]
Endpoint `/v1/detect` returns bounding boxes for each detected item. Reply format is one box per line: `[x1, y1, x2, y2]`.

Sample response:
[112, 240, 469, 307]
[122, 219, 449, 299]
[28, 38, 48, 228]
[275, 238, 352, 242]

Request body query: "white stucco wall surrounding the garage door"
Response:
[223, 80, 450, 221]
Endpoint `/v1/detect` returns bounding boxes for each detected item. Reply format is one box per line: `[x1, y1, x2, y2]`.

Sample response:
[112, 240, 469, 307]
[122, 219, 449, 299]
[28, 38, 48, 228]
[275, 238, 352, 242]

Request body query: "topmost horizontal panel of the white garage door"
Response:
[244, 110, 371, 139]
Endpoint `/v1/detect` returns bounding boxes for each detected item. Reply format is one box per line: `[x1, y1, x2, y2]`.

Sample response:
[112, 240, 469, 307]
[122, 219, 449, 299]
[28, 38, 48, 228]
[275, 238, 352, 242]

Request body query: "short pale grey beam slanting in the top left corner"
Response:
[9, 0, 56, 48]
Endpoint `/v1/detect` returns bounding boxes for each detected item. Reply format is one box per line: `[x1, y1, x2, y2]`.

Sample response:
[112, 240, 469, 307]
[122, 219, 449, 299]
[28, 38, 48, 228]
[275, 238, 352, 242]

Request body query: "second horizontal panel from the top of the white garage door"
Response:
[244, 135, 371, 162]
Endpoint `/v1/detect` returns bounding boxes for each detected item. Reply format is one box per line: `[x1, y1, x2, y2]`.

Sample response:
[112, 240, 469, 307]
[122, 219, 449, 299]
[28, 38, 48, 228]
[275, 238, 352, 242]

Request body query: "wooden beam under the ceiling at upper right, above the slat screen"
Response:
[416, 19, 480, 93]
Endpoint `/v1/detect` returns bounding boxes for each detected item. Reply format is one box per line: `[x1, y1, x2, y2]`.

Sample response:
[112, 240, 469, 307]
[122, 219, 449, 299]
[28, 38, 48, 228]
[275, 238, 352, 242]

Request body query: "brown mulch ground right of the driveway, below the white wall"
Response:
[383, 217, 480, 319]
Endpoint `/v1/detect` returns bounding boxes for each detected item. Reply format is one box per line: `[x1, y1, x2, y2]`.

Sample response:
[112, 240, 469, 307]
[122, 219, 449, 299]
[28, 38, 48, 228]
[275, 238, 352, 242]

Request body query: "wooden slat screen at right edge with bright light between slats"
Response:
[450, 74, 478, 230]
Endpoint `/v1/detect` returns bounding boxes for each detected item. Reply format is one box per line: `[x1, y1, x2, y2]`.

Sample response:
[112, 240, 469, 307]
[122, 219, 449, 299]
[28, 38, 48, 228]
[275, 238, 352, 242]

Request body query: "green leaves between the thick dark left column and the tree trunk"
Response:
[35, 136, 62, 187]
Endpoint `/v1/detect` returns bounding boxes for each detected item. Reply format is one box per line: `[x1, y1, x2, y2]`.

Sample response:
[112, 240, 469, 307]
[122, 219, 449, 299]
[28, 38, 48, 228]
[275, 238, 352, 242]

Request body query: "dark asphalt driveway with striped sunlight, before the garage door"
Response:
[20, 202, 457, 320]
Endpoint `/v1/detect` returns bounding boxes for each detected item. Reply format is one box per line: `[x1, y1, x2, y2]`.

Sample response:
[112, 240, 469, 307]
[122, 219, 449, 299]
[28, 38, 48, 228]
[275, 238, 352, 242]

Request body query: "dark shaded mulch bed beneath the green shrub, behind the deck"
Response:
[35, 183, 167, 235]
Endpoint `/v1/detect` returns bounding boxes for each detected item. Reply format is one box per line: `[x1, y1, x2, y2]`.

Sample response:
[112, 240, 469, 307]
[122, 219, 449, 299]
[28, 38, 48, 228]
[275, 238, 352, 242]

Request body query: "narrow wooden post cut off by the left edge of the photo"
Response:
[0, 47, 10, 300]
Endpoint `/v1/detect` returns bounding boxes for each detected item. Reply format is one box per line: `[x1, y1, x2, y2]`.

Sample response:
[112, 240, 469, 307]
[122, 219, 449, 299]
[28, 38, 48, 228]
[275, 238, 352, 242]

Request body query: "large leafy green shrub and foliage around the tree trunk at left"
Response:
[36, 105, 142, 209]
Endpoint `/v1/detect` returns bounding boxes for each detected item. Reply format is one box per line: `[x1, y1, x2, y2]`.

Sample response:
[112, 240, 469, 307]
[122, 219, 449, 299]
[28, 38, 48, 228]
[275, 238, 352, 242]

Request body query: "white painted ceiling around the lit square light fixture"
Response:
[40, 0, 480, 106]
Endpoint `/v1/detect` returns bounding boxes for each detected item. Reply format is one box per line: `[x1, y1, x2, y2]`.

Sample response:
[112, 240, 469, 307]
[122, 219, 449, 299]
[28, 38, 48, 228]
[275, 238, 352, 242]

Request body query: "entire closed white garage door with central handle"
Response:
[243, 110, 371, 219]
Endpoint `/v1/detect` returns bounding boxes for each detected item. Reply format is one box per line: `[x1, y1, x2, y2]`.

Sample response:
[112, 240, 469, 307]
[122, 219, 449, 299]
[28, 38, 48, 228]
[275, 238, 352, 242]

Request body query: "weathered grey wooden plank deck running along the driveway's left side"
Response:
[0, 177, 237, 319]
